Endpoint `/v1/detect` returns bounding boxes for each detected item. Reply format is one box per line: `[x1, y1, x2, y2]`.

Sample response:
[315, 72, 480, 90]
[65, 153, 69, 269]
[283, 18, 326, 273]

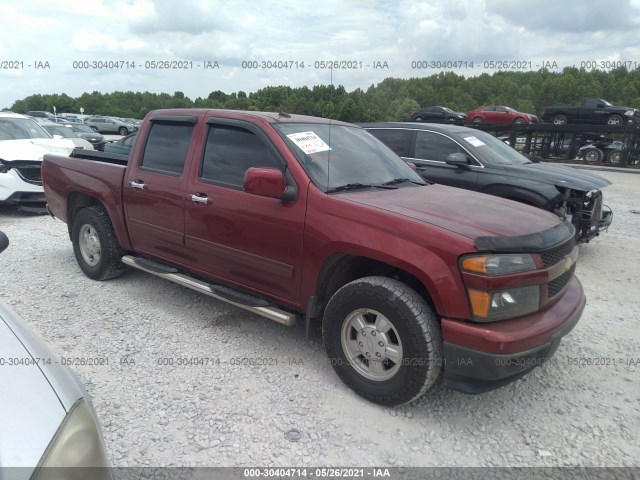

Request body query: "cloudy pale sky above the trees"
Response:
[0, 0, 640, 108]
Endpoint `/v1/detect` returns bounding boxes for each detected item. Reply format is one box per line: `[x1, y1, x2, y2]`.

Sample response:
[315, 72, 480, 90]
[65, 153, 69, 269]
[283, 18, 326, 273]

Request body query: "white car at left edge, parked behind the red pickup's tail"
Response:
[0, 112, 75, 210]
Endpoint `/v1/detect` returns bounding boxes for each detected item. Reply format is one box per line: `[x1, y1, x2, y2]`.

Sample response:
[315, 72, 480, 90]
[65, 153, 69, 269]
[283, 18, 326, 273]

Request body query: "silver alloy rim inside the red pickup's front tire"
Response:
[340, 308, 402, 382]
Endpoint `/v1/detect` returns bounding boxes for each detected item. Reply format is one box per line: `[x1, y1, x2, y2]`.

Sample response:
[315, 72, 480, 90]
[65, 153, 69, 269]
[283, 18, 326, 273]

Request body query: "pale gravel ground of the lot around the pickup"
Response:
[0, 172, 640, 467]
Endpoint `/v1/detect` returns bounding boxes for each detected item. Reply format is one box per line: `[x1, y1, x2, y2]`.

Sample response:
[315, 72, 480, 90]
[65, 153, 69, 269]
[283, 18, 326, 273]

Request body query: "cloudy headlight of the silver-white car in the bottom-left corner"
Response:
[32, 399, 111, 480]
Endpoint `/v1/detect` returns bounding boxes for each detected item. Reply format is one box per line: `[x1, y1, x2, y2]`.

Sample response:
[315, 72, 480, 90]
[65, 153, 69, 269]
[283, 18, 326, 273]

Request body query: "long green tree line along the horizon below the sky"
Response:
[10, 67, 640, 122]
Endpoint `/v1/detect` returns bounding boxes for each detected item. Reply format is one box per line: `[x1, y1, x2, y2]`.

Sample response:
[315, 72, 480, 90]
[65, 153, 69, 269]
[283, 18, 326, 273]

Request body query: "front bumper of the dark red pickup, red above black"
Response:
[442, 277, 586, 394]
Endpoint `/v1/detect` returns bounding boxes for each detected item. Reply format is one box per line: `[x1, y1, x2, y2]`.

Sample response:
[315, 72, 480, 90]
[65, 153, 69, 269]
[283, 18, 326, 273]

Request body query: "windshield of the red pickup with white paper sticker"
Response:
[274, 123, 425, 192]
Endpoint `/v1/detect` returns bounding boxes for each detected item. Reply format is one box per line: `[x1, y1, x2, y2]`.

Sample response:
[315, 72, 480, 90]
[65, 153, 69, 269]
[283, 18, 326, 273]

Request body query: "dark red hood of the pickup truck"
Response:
[340, 185, 562, 240]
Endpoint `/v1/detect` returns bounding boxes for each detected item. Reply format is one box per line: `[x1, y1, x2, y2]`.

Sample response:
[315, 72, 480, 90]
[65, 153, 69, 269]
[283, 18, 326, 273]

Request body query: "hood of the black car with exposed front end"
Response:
[504, 162, 611, 192]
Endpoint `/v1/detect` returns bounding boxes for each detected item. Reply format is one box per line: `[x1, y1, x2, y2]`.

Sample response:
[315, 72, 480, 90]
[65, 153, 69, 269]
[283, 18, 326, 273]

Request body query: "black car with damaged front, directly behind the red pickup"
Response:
[360, 123, 613, 242]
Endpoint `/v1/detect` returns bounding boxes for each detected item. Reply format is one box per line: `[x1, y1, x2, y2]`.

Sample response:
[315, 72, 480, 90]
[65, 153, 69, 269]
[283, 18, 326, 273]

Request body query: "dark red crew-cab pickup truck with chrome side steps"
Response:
[42, 109, 585, 405]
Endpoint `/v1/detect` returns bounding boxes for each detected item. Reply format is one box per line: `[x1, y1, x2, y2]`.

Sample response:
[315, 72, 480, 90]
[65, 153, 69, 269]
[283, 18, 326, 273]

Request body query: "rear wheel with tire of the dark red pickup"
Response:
[71, 207, 125, 280]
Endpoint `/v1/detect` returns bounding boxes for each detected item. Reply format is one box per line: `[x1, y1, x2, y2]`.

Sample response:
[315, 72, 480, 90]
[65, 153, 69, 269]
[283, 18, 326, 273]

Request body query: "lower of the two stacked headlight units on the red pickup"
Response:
[467, 285, 540, 322]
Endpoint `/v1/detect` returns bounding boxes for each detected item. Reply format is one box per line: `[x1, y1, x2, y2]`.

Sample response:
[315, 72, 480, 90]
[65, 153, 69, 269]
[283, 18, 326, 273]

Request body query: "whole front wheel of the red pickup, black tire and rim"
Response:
[322, 277, 442, 406]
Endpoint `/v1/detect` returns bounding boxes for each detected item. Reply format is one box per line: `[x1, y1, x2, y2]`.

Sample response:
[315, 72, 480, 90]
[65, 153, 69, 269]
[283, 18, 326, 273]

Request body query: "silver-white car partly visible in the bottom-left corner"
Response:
[0, 232, 111, 480]
